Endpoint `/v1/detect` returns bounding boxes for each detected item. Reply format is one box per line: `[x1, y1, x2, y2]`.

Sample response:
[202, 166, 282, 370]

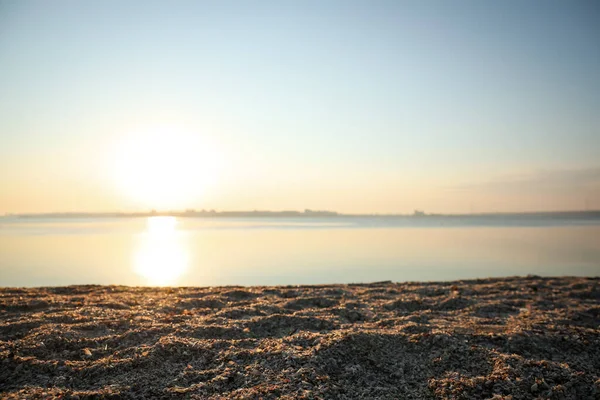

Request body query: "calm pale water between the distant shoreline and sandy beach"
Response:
[0, 217, 600, 286]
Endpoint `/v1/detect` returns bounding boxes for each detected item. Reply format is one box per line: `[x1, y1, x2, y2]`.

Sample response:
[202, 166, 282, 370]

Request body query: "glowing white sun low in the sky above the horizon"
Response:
[114, 127, 221, 210]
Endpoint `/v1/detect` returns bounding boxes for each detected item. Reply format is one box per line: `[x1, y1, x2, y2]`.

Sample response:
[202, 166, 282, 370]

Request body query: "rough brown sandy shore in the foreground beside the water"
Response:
[0, 277, 600, 399]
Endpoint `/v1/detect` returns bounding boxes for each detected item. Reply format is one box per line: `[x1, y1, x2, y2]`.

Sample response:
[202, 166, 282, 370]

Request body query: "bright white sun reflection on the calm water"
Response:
[133, 216, 189, 286]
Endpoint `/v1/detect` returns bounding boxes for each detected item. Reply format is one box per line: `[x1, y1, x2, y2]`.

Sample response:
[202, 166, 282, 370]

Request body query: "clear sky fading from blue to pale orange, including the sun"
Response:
[0, 0, 600, 214]
